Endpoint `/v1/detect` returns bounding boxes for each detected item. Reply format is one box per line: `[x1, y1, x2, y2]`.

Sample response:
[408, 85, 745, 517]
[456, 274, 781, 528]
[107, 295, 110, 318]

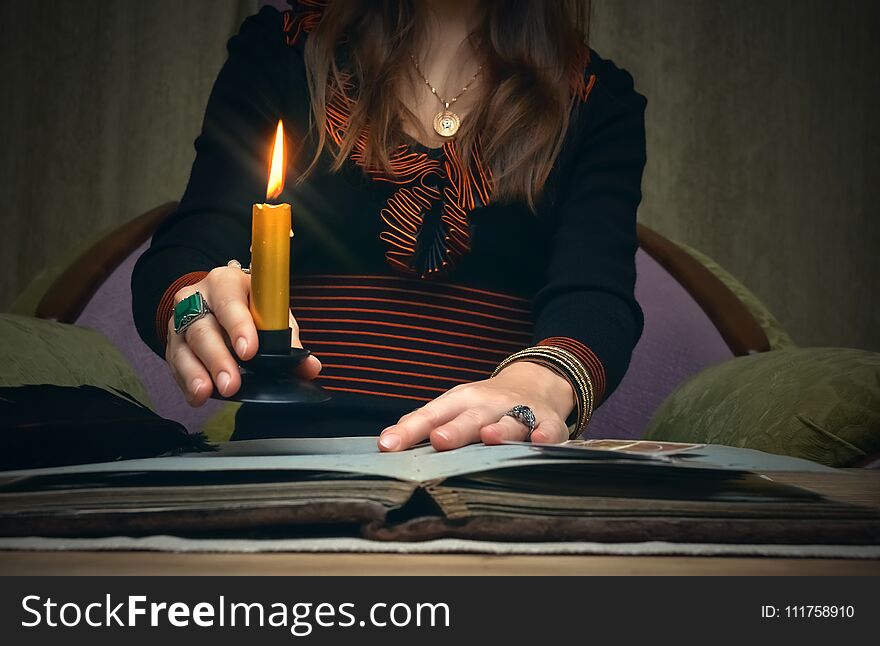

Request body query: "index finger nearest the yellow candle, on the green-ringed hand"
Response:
[206, 267, 259, 361]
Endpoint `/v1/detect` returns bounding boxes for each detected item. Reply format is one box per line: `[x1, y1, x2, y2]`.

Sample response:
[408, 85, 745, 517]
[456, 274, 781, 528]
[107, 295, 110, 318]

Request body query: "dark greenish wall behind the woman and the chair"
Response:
[0, 0, 880, 350]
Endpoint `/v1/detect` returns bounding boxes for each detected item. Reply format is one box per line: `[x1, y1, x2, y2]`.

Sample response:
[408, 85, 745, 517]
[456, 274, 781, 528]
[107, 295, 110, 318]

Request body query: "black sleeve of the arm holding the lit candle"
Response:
[132, 7, 293, 354]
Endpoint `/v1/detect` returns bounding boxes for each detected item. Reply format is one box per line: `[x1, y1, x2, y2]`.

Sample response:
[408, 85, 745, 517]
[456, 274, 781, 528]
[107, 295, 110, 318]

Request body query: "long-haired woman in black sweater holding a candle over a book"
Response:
[132, 0, 645, 451]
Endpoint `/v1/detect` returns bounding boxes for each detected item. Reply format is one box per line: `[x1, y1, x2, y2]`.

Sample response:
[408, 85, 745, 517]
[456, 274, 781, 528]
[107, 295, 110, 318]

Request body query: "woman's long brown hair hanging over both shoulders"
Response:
[305, 0, 590, 208]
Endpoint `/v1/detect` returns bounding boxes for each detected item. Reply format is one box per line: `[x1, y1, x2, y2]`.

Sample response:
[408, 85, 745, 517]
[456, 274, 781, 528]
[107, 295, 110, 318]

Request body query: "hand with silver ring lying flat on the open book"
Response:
[379, 361, 576, 451]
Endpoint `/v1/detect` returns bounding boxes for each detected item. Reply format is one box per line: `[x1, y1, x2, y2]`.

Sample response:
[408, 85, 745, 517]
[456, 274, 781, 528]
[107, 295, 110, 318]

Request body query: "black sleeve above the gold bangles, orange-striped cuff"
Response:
[534, 54, 647, 402]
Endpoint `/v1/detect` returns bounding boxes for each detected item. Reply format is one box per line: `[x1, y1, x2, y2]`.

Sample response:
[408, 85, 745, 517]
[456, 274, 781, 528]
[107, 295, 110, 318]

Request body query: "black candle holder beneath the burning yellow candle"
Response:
[214, 328, 330, 405]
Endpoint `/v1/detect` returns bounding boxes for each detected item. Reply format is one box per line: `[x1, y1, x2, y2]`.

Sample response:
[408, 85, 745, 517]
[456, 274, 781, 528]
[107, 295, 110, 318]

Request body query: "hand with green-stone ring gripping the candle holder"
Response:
[165, 267, 321, 406]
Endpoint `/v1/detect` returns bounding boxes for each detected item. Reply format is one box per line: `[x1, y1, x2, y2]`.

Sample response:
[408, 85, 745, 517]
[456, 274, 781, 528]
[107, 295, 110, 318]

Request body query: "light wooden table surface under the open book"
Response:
[0, 469, 880, 576]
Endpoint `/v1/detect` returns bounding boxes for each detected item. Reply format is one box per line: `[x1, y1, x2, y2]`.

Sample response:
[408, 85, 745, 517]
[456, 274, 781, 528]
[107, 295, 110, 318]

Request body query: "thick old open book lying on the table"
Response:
[0, 438, 880, 543]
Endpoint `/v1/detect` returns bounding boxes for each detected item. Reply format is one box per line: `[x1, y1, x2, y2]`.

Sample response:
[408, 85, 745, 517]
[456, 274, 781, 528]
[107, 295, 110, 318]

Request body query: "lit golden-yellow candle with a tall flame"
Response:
[250, 121, 293, 353]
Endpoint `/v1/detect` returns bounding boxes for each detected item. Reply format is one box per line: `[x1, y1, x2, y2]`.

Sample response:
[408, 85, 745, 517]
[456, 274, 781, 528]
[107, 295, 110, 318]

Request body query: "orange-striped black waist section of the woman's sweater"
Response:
[291, 275, 532, 402]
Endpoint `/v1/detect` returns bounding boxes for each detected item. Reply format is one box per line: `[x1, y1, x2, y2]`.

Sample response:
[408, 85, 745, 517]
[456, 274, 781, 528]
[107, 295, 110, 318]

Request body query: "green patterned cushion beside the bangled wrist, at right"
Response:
[646, 348, 880, 467]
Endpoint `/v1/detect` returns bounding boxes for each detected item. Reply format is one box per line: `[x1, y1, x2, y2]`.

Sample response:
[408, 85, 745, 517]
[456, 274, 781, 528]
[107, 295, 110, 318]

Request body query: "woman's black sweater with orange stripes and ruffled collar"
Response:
[132, 3, 646, 434]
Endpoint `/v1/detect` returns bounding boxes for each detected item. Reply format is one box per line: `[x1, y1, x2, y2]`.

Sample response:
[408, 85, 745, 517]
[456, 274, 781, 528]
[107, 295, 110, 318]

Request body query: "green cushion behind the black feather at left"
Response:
[0, 314, 150, 406]
